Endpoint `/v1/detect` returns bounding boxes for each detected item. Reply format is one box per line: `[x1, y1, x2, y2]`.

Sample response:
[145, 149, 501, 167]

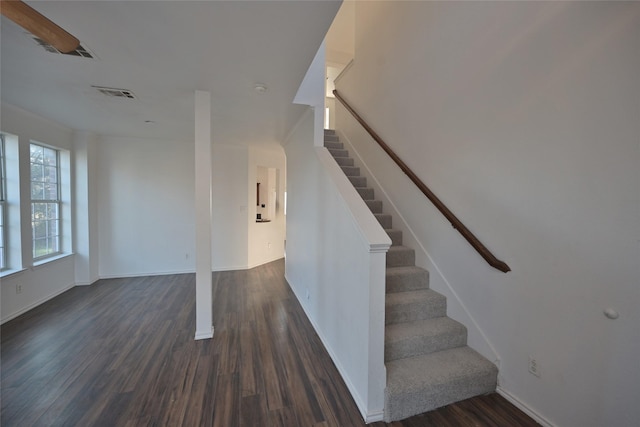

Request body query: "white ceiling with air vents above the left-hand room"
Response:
[0, 0, 340, 144]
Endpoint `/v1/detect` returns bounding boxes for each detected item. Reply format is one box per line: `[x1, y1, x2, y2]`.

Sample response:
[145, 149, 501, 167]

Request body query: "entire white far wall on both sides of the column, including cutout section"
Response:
[98, 137, 286, 277]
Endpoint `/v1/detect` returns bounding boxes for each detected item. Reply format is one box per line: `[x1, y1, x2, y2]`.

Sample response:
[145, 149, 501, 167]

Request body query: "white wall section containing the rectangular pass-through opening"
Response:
[246, 147, 287, 268]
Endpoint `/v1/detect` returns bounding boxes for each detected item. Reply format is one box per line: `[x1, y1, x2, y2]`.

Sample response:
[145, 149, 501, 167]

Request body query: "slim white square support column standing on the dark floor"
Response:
[195, 90, 213, 340]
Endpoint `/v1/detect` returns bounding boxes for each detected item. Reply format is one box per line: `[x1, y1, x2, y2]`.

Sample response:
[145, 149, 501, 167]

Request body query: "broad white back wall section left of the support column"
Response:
[97, 137, 195, 277]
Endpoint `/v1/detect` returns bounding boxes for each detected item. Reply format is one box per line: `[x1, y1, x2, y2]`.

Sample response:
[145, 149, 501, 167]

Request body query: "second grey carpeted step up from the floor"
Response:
[384, 317, 467, 361]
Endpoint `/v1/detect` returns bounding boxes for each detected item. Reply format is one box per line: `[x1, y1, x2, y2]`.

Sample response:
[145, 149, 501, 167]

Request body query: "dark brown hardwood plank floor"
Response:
[0, 260, 537, 427]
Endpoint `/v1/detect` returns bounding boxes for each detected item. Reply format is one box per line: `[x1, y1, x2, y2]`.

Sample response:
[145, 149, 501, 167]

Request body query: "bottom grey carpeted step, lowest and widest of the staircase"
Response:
[384, 346, 498, 422]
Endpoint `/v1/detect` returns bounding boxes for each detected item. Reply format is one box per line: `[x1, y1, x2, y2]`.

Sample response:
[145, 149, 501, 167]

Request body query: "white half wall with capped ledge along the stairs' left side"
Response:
[285, 110, 391, 421]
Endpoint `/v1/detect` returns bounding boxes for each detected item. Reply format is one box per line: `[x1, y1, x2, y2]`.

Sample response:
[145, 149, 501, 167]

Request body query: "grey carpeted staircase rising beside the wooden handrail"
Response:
[324, 130, 498, 422]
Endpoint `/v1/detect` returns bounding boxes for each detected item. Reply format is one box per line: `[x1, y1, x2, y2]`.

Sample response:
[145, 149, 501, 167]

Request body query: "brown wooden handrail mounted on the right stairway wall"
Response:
[333, 90, 511, 273]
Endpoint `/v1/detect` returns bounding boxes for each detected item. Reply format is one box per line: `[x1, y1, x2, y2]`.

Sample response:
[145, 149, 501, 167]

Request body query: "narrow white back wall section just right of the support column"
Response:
[211, 143, 249, 271]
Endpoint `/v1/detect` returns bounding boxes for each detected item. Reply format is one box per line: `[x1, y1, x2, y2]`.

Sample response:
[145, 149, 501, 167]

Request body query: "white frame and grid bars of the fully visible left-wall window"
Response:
[29, 142, 63, 262]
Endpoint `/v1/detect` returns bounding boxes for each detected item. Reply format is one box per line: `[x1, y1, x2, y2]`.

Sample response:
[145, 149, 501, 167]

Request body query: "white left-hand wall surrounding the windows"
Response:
[0, 104, 75, 322]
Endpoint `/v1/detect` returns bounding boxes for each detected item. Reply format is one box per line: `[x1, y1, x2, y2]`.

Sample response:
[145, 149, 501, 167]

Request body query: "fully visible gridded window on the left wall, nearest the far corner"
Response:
[30, 144, 61, 261]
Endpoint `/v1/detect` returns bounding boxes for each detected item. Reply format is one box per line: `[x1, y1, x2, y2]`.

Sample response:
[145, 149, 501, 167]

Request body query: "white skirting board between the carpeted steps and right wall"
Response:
[336, 129, 501, 372]
